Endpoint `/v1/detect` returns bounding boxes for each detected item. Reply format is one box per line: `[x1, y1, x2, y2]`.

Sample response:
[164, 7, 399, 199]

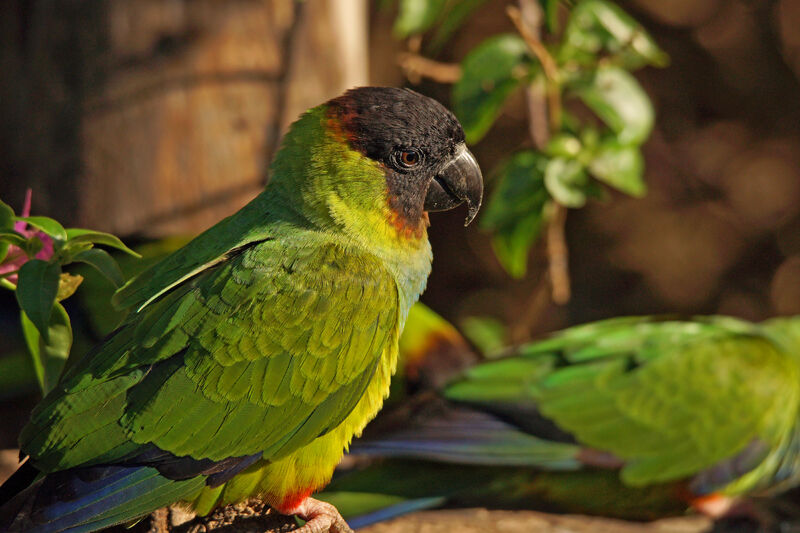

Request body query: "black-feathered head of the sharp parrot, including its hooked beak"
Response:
[328, 87, 483, 225]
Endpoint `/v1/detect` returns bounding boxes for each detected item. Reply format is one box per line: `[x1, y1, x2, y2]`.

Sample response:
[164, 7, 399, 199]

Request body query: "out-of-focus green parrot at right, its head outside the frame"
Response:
[320, 316, 800, 527]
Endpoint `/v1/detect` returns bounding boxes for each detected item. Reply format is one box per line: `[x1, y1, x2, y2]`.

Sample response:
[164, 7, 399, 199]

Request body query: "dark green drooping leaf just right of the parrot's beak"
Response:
[481, 150, 549, 278]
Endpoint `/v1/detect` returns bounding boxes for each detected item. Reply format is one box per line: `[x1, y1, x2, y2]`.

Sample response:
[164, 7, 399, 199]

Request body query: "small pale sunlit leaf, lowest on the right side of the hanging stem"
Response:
[589, 139, 647, 198]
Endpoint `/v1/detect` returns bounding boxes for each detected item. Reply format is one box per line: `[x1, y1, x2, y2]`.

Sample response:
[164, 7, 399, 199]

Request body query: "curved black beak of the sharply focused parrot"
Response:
[424, 144, 483, 226]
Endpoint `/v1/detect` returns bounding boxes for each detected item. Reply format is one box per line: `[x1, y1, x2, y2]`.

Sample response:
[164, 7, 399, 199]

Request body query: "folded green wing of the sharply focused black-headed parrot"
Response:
[21, 234, 398, 471]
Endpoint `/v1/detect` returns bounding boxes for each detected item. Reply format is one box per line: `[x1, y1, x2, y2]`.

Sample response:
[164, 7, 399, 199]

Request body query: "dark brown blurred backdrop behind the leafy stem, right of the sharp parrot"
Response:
[390, 0, 800, 340]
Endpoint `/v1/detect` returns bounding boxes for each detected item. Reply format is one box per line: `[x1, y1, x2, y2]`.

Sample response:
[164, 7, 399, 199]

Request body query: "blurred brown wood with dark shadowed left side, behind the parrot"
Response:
[0, 0, 368, 236]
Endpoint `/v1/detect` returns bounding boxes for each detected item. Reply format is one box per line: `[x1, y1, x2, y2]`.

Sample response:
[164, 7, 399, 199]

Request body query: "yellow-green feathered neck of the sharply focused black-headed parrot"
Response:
[263, 106, 432, 322]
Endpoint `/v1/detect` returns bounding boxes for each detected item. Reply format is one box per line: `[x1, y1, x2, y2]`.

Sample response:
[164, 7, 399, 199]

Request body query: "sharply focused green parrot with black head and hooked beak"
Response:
[0, 87, 483, 533]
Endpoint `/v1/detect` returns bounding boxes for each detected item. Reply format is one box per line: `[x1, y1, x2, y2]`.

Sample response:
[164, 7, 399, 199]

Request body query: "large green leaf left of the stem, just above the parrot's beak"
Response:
[453, 34, 533, 143]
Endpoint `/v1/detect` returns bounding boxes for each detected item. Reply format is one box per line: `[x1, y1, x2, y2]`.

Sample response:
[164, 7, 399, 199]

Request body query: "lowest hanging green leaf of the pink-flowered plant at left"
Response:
[20, 303, 72, 395]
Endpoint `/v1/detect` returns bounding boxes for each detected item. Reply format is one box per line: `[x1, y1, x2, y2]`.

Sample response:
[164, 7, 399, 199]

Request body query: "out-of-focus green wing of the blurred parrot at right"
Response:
[445, 317, 800, 486]
